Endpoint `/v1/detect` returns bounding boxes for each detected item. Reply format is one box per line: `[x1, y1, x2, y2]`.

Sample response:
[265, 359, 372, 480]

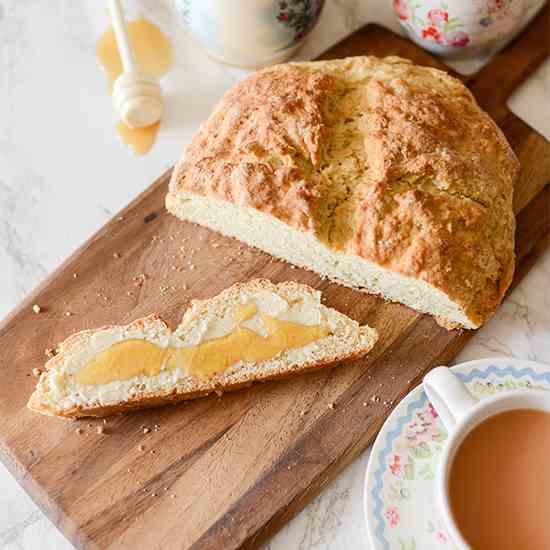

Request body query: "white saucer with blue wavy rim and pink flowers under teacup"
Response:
[364, 359, 550, 550]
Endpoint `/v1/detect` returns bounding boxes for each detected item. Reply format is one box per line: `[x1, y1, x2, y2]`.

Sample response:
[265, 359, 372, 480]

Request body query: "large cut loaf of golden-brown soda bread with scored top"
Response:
[166, 57, 518, 328]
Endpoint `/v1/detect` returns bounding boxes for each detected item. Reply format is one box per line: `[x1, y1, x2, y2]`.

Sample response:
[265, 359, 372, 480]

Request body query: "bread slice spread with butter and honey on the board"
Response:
[28, 279, 378, 418]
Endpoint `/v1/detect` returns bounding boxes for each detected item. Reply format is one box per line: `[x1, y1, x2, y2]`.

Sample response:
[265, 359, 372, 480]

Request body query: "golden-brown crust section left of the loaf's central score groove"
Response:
[171, 65, 331, 233]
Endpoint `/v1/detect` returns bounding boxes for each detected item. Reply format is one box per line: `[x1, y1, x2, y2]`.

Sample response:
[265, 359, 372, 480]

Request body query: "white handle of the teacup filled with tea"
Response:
[423, 367, 477, 431]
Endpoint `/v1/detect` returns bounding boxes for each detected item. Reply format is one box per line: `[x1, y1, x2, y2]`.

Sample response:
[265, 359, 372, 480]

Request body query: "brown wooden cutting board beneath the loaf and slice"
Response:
[0, 9, 550, 550]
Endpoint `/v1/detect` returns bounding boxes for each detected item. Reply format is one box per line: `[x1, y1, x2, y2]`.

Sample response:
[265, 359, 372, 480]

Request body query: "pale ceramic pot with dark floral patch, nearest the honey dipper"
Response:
[175, 0, 324, 68]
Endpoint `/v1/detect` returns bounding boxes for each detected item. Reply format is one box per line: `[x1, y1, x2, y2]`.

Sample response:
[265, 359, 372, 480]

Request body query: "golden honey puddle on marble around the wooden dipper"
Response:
[96, 17, 172, 155]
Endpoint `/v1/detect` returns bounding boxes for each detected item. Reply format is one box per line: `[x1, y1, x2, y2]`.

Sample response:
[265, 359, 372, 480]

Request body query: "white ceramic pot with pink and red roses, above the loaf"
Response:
[393, 0, 526, 57]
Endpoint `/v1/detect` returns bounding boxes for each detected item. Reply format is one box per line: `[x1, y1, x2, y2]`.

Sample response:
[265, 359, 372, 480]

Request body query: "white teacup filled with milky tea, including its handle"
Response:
[424, 367, 550, 550]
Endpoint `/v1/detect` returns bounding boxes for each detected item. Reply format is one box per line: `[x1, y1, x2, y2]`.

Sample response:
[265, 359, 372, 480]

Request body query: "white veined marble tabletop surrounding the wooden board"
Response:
[0, 0, 550, 550]
